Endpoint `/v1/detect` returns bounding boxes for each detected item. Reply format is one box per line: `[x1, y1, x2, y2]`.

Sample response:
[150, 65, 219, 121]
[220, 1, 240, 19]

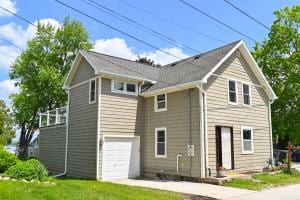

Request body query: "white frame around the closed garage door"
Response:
[102, 135, 141, 180]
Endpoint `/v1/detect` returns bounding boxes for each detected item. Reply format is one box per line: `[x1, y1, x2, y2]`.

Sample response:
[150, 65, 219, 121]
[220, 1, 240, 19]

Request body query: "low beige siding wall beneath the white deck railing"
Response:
[39, 125, 66, 175]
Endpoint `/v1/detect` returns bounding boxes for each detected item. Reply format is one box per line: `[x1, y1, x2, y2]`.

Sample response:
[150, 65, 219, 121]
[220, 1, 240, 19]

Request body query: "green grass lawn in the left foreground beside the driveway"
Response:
[0, 179, 182, 200]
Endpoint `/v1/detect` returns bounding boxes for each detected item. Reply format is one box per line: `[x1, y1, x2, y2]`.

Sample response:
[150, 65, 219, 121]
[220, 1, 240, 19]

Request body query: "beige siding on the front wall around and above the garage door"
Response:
[99, 78, 144, 177]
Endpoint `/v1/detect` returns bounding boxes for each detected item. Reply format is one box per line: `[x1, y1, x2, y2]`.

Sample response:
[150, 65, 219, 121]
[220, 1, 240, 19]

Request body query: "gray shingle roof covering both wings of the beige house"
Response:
[81, 41, 240, 92]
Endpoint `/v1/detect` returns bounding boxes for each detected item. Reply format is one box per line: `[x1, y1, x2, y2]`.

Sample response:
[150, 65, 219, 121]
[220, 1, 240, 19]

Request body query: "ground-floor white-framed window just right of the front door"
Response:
[241, 126, 253, 154]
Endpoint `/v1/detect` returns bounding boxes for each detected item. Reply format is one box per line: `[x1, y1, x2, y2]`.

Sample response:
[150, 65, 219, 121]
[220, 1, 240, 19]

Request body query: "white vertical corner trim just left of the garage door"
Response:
[96, 77, 102, 179]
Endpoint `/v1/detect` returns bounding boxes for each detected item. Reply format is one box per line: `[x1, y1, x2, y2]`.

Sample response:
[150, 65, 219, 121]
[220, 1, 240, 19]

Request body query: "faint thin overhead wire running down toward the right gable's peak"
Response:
[116, 0, 228, 44]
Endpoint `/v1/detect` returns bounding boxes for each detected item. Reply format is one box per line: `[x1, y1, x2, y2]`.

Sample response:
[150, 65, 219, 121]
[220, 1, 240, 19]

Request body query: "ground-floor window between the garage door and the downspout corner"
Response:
[155, 128, 167, 158]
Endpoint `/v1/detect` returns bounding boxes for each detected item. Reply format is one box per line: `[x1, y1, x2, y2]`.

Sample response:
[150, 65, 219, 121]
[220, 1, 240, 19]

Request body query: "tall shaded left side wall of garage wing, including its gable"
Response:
[67, 65, 98, 178]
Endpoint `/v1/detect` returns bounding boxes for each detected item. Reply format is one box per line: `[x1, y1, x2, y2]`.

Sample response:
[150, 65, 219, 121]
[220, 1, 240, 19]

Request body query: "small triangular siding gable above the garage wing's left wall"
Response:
[70, 58, 95, 87]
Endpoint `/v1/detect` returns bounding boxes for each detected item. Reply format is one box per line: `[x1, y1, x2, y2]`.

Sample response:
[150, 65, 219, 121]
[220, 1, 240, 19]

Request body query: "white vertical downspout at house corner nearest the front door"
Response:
[198, 82, 205, 178]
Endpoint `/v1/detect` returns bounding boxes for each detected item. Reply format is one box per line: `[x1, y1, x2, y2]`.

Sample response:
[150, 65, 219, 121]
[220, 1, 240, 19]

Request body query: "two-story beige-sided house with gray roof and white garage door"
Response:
[39, 41, 277, 180]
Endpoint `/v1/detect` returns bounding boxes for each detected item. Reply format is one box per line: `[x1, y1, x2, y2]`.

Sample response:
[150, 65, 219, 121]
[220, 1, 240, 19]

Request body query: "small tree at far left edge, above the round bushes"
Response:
[0, 100, 15, 145]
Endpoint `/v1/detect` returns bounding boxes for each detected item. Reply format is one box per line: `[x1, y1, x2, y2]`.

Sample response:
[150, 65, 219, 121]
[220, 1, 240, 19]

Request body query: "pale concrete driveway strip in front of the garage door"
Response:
[112, 179, 255, 199]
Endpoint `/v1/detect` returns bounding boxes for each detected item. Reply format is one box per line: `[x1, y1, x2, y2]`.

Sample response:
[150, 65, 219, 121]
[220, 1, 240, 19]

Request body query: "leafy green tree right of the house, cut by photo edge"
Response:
[253, 5, 300, 146]
